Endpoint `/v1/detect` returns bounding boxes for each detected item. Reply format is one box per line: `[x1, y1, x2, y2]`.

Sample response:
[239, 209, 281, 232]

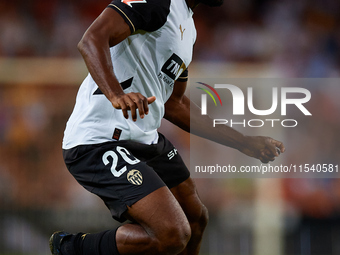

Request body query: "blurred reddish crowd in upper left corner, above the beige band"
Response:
[0, 0, 108, 57]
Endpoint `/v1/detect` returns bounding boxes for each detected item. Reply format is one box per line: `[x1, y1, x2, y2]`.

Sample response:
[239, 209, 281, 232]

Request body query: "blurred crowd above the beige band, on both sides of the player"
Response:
[0, 0, 340, 77]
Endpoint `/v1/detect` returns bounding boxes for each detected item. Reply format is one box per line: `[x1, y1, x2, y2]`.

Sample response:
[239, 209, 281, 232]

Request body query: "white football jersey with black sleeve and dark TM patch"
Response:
[63, 0, 196, 149]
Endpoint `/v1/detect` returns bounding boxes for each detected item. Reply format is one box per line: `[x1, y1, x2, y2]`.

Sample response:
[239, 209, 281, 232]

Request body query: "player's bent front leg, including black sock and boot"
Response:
[50, 187, 191, 255]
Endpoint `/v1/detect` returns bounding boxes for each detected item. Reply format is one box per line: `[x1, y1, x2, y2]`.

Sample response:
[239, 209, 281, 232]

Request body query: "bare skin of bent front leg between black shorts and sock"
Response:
[116, 187, 191, 255]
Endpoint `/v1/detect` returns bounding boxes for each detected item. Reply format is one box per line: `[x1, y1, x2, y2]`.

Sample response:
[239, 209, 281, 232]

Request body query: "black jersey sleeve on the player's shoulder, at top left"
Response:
[108, 0, 171, 33]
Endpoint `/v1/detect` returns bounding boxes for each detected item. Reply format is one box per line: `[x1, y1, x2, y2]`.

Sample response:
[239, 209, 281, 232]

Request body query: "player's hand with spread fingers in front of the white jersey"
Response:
[111, 92, 156, 121]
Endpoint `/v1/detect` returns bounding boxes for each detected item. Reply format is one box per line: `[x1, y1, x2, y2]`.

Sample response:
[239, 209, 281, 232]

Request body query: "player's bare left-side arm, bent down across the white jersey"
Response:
[78, 8, 156, 120]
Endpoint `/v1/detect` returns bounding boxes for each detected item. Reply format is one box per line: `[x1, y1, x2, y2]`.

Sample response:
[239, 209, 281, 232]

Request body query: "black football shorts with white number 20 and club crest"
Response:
[63, 133, 190, 222]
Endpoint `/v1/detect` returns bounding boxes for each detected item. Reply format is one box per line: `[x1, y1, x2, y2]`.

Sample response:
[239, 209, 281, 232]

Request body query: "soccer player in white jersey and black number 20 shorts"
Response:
[50, 0, 285, 255]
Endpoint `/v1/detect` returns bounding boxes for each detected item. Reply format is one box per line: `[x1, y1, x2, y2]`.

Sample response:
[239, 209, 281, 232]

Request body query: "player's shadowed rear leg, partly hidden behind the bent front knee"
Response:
[171, 178, 208, 255]
